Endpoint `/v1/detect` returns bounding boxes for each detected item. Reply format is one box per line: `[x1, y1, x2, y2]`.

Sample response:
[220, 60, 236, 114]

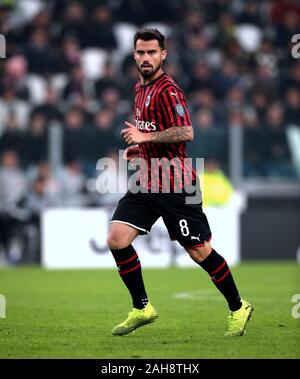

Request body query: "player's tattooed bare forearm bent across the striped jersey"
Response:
[146, 125, 194, 143]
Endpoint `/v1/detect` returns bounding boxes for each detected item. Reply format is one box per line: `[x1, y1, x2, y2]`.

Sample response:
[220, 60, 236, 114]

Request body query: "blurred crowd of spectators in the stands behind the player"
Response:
[0, 0, 300, 260]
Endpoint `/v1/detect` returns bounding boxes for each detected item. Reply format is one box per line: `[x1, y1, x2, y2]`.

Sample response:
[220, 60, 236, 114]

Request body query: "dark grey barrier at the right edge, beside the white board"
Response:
[241, 191, 300, 262]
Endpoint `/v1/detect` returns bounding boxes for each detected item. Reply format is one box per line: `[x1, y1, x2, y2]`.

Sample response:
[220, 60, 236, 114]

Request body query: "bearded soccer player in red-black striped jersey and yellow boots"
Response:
[107, 29, 253, 336]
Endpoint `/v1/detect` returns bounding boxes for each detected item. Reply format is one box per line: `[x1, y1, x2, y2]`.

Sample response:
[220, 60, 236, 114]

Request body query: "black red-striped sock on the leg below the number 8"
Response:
[199, 249, 242, 311]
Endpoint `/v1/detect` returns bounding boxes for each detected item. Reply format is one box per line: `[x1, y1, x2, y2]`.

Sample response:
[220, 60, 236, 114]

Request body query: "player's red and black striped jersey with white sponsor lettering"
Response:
[134, 73, 196, 192]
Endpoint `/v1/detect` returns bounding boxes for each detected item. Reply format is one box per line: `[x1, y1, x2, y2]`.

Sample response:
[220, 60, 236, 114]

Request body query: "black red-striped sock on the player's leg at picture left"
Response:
[111, 245, 148, 309]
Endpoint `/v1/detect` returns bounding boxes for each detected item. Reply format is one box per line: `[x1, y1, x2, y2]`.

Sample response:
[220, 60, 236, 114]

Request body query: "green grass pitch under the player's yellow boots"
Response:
[0, 262, 300, 359]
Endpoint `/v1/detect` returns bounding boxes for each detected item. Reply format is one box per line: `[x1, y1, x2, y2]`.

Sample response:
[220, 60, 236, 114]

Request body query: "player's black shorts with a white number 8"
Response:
[111, 192, 211, 247]
